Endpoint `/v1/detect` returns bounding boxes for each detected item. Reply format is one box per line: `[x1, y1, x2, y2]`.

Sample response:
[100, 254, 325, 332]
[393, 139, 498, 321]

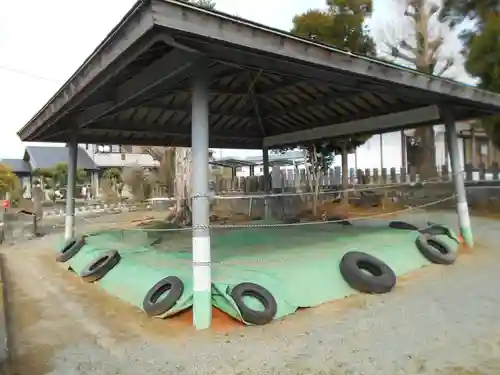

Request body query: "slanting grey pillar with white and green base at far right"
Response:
[443, 109, 474, 248]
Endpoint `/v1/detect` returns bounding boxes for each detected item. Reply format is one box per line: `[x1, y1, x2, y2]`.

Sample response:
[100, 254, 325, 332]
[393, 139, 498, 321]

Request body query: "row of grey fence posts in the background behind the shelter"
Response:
[214, 162, 500, 194]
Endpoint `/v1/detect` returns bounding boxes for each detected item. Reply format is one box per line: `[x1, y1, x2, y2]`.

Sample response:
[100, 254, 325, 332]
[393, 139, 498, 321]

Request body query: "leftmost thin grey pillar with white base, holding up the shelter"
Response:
[64, 131, 78, 241]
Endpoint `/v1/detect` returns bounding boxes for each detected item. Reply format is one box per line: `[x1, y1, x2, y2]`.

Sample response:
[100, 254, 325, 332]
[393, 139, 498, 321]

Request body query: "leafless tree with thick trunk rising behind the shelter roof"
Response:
[373, 0, 461, 178]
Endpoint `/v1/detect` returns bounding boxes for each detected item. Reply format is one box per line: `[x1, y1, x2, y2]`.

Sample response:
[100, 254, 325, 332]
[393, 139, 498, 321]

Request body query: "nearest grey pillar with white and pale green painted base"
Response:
[191, 62, 212, 329]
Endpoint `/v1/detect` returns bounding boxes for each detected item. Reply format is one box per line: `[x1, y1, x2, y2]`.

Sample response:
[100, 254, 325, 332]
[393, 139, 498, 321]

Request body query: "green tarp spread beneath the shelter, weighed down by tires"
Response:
[56, 224, 458, 320]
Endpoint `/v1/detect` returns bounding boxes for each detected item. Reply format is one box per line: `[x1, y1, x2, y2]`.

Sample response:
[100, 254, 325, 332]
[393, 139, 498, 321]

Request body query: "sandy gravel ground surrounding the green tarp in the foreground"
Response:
[5, 213, 500, 375]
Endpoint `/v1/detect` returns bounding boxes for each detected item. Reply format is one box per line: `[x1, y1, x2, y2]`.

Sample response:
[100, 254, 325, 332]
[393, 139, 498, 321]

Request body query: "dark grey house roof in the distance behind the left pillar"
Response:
[24, 146, 99, 170]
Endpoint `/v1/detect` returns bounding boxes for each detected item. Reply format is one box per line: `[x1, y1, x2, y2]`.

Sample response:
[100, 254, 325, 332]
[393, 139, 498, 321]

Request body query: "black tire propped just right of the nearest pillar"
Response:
[231, 283, 278, 325]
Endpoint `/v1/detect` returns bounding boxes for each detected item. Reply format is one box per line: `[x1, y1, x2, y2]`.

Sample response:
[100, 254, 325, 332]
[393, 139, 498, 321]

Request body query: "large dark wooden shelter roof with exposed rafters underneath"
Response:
[18, 0, 500, 149]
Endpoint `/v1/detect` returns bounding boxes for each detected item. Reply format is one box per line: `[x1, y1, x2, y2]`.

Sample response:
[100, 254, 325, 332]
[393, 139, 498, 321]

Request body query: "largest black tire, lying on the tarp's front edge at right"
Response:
[339, 251, 396, 294]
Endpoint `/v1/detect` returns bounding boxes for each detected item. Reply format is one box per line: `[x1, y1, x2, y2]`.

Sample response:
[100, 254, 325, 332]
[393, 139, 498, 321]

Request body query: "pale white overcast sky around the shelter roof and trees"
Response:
[0, 0, 476, 159]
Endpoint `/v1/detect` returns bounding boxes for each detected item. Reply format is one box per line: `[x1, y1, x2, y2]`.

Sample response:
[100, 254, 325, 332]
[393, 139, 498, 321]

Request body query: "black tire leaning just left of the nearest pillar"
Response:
[142, 276, 184, 318]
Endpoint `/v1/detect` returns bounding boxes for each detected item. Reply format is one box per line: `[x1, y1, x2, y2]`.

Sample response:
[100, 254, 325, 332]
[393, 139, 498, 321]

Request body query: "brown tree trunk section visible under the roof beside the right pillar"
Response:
[415, 126, 436, 180]
